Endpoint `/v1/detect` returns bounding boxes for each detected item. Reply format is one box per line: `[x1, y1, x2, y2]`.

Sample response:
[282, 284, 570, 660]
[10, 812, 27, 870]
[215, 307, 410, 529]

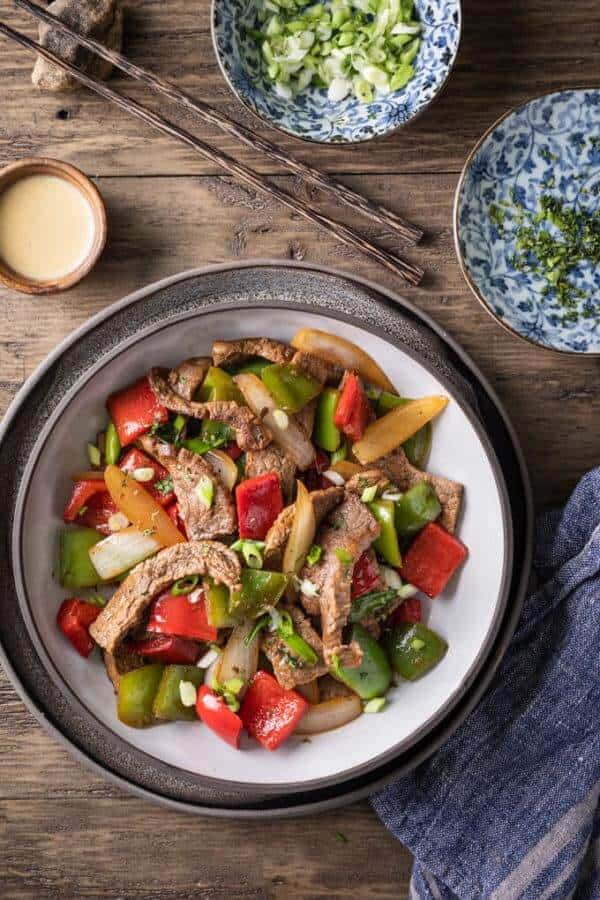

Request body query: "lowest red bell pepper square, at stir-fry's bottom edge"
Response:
[240, 671, 308, 750]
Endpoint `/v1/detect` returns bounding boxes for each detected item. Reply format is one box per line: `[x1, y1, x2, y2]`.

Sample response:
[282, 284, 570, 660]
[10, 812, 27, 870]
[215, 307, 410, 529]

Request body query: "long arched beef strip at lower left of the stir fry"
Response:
[90, 541, 242, 655]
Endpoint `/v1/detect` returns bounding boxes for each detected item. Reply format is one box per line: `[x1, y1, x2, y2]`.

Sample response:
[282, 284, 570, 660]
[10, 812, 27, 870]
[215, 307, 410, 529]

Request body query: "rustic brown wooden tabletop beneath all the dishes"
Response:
[0, 0, 600, 900]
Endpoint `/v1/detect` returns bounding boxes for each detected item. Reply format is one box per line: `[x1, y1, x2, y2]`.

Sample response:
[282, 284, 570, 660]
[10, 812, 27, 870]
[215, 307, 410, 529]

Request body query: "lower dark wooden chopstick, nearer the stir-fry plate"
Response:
[0, 22, 424, 286]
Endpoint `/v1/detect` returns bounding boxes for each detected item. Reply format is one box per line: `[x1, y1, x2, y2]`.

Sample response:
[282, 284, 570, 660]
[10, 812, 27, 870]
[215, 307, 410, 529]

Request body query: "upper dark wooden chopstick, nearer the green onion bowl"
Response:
[15, 0, 423, 244]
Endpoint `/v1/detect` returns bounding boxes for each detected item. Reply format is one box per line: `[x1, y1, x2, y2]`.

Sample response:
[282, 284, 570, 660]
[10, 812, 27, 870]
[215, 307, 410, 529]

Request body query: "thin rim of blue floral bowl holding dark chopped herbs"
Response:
[452, 83, 600, 359]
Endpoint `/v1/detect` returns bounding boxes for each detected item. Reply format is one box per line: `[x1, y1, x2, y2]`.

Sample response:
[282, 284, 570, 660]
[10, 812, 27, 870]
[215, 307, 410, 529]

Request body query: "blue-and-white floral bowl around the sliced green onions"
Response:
[212, 0, 461, 144]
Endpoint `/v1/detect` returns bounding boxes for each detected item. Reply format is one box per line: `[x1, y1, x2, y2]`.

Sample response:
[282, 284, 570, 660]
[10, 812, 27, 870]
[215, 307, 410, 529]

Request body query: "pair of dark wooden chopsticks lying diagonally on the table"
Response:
[0, 0, 424, 286]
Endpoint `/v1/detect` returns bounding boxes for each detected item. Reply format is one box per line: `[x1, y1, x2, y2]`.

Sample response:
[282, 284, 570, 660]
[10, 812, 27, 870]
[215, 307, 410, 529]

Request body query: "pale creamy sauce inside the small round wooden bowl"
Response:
[0, 175, 94, 281]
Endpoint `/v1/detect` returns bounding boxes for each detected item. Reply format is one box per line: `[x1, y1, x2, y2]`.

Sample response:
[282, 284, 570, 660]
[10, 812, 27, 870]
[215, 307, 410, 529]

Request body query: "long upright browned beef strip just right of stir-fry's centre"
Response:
[300, 493, 380, 666]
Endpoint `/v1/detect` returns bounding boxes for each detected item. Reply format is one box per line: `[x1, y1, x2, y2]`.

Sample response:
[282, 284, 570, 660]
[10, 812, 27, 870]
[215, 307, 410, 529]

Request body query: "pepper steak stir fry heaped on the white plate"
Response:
[58, 329, 467, 750]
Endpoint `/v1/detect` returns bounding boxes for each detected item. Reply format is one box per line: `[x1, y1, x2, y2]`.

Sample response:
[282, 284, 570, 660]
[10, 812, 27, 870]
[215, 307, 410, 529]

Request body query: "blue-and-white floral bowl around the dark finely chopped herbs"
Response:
[454, 89, 600, 354]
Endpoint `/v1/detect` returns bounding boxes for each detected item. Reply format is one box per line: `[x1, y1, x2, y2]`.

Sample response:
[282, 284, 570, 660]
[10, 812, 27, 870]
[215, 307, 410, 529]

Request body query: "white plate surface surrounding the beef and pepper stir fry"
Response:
[13, 307, 512, 789]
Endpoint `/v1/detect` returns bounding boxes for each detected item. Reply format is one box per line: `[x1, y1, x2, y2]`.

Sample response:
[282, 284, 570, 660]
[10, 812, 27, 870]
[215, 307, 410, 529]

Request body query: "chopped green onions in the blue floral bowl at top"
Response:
[250, 0, 421, 104]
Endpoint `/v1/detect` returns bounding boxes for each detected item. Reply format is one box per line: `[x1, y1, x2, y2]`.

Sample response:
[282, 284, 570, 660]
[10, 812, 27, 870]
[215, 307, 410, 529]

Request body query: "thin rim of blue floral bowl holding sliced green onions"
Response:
[210, 0, 463, 147]
